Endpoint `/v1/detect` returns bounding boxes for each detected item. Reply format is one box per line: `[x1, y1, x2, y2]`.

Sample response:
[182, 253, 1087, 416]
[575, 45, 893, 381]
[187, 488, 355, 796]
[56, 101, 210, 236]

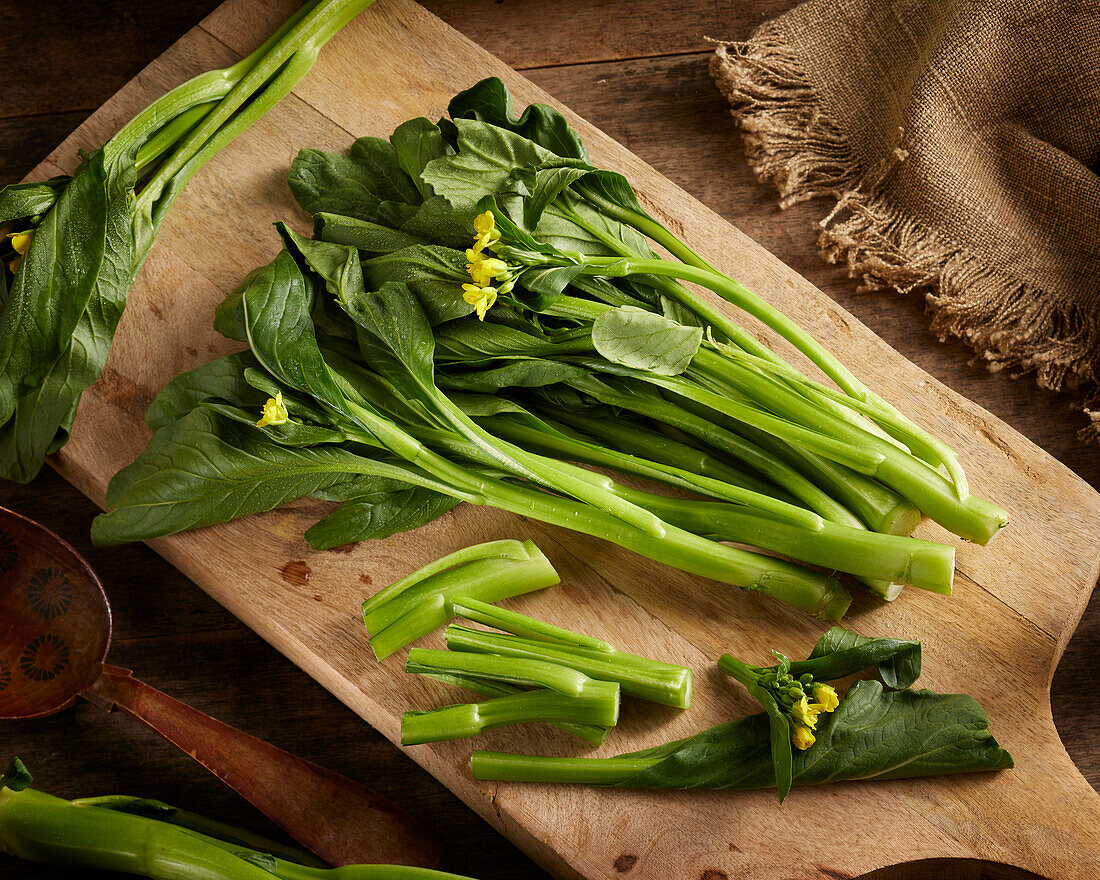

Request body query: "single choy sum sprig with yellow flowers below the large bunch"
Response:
[471, 627, 1013, 801]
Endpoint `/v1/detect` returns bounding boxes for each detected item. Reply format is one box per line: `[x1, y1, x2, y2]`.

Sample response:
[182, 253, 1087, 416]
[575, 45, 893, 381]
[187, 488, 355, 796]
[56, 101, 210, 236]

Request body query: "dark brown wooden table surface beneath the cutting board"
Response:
[0, 0, 1100, 880]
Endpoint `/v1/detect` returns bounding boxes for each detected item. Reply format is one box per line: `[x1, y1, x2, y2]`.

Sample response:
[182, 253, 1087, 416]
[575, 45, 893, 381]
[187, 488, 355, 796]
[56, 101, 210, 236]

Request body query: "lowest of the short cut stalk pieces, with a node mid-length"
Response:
[402, 680, 619, 746]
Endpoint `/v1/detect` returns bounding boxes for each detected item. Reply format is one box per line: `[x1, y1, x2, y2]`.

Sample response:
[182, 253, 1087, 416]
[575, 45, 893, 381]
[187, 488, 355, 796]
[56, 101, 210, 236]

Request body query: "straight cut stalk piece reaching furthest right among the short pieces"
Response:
[443, 624, 692, 708]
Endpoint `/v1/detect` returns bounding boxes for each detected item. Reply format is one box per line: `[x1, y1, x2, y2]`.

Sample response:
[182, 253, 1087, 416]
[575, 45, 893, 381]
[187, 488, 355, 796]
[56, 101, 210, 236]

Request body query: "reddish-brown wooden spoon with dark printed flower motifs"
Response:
[0, 507, 442, 868]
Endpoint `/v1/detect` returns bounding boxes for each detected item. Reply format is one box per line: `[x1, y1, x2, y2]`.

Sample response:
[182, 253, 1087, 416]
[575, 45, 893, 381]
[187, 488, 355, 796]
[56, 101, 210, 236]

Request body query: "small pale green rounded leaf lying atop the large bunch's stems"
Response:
[592, 306, 703, 376]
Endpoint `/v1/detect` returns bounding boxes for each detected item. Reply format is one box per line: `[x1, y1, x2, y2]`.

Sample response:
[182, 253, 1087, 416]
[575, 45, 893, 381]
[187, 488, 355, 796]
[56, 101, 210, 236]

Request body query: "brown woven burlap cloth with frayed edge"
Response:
[711, 0, 1100, 438]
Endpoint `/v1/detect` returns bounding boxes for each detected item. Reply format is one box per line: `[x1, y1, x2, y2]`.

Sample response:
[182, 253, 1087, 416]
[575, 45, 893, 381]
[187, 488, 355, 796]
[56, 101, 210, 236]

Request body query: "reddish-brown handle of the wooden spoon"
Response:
[81, 664, 442, 868]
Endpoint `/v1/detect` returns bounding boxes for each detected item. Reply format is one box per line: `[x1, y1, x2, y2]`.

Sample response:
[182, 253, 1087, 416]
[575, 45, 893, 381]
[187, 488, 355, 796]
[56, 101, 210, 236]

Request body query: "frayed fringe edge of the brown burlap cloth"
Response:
[711, 41, 1100, 441]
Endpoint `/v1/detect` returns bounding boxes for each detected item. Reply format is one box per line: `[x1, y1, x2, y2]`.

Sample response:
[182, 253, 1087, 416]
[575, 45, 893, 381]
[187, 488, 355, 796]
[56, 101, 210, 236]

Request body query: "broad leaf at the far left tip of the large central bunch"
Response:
[91, 407, 378, 546]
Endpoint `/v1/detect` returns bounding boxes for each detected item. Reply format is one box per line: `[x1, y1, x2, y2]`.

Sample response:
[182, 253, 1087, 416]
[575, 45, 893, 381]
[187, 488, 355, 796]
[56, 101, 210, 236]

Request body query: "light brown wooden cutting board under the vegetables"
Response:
[32, 0, 1100, 880]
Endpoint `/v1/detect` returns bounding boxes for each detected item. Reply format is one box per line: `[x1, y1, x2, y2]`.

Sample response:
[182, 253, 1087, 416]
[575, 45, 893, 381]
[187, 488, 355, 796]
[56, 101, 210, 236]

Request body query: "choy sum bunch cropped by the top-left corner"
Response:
[0, 0, 373, 483]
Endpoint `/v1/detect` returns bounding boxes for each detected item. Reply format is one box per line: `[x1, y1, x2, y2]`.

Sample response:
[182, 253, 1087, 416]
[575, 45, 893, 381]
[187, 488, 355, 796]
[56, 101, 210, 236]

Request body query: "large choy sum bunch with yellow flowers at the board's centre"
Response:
[94, 79, 1007, 619]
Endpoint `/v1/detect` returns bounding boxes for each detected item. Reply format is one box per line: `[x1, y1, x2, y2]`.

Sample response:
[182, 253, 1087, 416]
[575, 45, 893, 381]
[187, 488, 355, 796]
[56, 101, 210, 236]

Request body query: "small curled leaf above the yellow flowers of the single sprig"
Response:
[791, 626, 921, 690]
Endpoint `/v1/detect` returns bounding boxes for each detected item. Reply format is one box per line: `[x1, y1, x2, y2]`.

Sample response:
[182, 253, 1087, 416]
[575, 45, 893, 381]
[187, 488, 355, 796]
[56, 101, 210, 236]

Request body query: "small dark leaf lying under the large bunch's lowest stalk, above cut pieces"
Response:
[306, 486, 459, 550]
